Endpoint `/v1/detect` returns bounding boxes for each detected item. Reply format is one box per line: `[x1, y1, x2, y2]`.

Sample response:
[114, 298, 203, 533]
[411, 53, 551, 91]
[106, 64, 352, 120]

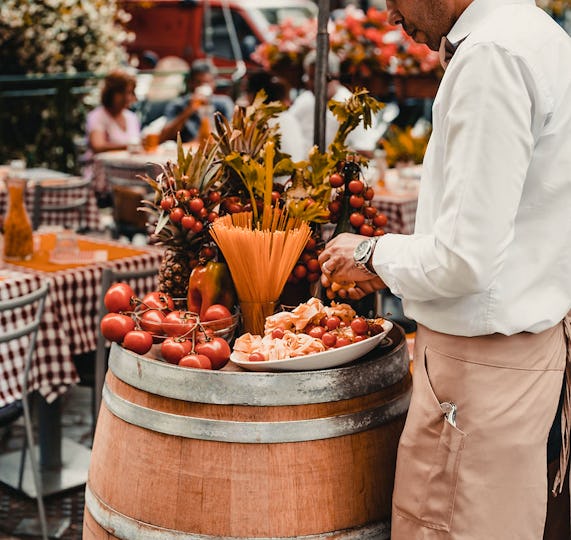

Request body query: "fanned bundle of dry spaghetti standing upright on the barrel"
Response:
[210, 206, 311, 334]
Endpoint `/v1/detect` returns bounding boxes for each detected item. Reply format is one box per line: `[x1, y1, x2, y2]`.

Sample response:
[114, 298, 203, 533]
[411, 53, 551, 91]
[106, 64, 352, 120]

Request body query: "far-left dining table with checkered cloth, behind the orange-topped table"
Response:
[0, 167, 103, 231]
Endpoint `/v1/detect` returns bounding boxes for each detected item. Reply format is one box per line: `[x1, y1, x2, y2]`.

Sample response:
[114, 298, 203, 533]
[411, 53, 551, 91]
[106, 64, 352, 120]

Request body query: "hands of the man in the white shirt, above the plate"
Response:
[319, 233, 386, 300]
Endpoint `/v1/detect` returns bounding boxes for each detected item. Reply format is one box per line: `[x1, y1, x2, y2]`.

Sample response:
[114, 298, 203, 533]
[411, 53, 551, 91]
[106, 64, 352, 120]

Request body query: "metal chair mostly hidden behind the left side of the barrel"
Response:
[93, 268, 159, 428]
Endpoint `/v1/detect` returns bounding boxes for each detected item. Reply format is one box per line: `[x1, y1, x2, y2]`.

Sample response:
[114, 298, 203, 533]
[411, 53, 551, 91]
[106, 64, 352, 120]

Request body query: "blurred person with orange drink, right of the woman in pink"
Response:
[160, 60, 234, 142]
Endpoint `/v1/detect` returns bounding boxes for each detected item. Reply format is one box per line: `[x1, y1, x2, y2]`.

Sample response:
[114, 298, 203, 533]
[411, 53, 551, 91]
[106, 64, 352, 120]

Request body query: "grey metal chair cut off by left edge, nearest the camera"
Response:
[0, 282, 49, 540]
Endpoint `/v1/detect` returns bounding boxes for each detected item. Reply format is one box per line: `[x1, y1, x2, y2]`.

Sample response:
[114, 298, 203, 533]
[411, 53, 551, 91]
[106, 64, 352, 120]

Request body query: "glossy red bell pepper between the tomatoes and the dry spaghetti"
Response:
[187, 261, 236, 317]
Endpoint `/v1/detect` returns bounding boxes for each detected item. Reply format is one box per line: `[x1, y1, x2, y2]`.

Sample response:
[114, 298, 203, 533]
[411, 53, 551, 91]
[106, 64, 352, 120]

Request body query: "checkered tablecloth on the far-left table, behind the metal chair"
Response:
[0, 169, 103, 231]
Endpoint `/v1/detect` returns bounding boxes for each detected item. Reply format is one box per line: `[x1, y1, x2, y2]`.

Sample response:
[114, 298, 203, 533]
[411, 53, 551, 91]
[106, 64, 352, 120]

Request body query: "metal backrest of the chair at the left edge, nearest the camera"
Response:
[0, 281, 49, 393]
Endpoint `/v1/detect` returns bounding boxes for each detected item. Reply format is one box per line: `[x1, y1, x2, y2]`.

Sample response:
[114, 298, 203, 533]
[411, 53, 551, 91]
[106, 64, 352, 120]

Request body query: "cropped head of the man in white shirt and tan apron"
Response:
[387, 0, 473, 51]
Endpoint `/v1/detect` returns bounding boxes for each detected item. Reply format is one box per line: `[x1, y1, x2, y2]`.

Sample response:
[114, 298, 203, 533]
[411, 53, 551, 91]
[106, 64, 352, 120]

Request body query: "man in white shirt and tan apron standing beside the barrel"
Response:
[320, 0, 571, 540]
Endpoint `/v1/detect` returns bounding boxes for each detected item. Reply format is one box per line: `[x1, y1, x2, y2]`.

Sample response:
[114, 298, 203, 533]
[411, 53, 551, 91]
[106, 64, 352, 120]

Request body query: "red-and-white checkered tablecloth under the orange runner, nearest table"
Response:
[0, 238, 162, 407]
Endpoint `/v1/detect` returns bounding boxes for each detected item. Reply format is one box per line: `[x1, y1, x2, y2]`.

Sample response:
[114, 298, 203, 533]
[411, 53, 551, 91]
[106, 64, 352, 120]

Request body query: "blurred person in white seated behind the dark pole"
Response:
[291, 51, 378, 157]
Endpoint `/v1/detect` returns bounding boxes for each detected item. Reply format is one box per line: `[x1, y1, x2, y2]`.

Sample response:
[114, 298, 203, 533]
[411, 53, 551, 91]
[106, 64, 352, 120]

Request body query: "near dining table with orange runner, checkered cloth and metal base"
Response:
[0, 233, 163, 496]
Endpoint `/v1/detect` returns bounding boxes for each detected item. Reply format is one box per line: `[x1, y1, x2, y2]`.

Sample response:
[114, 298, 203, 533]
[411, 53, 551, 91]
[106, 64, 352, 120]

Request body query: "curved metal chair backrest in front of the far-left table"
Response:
[32, 177, 91, 230]
